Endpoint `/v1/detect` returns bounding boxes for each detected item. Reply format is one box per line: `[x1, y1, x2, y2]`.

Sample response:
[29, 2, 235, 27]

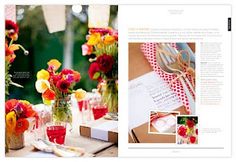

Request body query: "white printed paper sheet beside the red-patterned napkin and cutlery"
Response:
[129, 72, 182, 129]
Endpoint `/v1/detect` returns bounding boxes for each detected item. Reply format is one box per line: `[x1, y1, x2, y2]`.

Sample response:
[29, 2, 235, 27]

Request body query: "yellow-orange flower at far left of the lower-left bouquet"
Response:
[6, 111, 16, 134]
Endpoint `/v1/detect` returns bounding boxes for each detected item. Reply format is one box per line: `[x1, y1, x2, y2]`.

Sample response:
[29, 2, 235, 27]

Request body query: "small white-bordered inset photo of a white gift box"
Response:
[148, 111, 179, 134]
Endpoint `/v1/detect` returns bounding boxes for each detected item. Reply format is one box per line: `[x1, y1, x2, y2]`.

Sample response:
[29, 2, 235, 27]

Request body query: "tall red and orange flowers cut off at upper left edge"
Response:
[5, 20, 29, 95]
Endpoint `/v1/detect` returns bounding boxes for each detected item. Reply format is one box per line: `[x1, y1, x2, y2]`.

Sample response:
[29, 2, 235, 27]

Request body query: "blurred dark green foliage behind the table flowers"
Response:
[9, 6, 118, 104]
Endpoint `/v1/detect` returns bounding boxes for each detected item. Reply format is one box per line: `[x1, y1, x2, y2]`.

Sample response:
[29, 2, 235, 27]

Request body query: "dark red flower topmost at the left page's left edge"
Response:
[5, 20, 19, 40]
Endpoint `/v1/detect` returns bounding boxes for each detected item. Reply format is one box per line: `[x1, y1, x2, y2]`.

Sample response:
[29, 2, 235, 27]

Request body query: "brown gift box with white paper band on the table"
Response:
[80, 118, 118, 143]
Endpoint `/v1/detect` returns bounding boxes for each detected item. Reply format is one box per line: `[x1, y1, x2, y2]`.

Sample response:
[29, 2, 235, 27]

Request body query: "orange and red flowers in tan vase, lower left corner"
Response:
[5, 99, 38, 150]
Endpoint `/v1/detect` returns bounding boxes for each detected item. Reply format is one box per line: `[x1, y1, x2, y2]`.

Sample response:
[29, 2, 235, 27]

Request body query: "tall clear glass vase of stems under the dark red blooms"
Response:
[102, 79, 118, 120]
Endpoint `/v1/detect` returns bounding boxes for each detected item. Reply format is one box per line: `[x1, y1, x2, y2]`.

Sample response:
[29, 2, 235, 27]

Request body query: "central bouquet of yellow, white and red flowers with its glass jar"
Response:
[35, 59, 85, 123]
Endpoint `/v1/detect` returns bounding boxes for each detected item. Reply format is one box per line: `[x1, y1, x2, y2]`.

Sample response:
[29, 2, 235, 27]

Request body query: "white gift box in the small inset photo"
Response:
[152, 115, 176, 133]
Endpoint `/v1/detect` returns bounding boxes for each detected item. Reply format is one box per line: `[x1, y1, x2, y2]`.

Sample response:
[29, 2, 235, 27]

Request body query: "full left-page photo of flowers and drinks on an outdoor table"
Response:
[5, 5, 118, 158]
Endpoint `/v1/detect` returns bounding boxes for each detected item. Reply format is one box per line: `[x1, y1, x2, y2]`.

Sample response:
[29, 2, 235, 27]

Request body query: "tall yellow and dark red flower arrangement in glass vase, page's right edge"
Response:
[82, 28, 118, 117]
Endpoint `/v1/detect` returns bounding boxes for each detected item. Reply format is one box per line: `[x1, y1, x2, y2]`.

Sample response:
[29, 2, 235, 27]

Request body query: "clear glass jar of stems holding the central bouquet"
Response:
[52, 96, 72, 123]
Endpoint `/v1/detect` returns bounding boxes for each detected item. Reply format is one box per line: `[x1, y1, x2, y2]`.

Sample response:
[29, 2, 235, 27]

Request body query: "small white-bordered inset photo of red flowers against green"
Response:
[177, 117, 198, 144]
